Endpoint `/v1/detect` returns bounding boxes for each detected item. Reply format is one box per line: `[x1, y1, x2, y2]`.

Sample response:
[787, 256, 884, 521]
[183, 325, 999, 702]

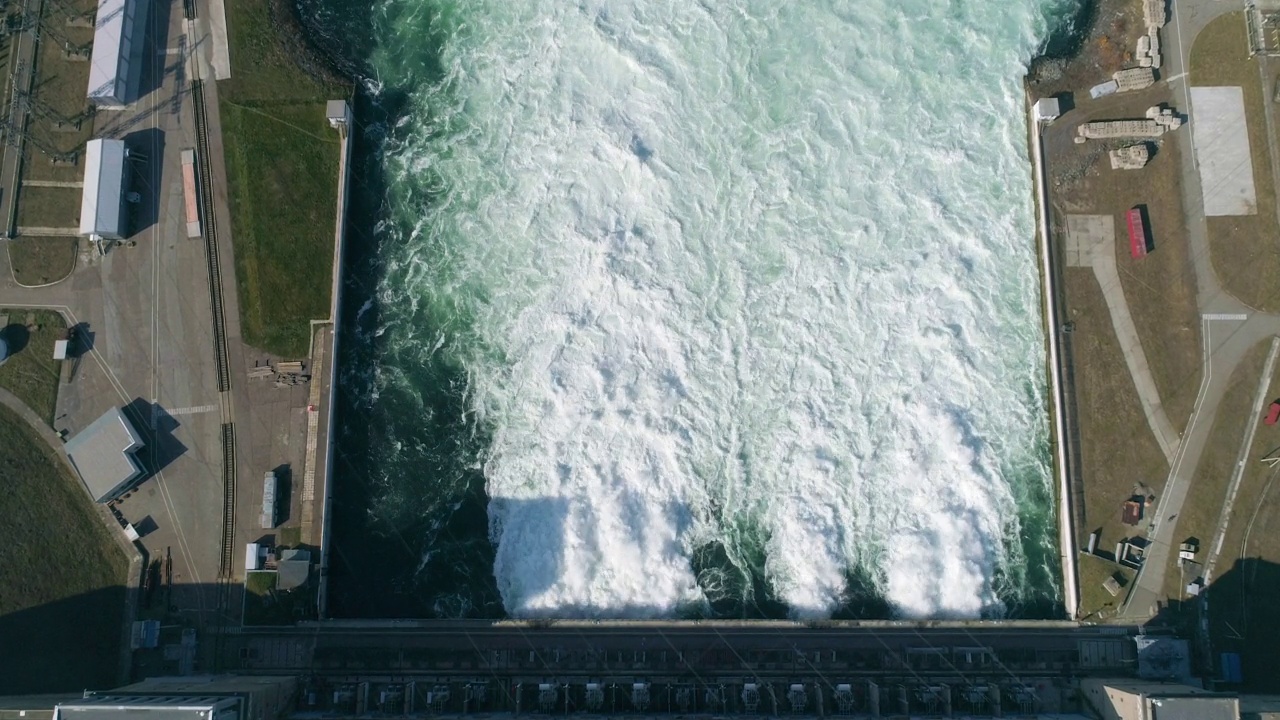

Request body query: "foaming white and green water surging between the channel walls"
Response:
[375, 0, 1064, 618]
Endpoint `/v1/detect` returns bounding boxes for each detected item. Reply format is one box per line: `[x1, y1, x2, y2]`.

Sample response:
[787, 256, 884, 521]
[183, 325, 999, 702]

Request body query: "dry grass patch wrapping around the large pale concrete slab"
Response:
[1190, 13, 1280, 313]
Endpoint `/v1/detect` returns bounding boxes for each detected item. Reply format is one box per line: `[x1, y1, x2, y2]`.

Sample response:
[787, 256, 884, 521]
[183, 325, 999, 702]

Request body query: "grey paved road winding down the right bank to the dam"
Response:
[1120, 0, 1280, 620]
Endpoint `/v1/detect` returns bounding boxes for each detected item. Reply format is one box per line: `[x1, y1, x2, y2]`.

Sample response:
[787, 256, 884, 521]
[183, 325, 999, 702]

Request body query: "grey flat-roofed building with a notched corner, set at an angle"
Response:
[67, 407, 146, 502]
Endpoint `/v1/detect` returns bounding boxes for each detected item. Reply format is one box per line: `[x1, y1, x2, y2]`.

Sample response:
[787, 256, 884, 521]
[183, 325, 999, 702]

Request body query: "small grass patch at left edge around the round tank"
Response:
[0, 309, 67, 420]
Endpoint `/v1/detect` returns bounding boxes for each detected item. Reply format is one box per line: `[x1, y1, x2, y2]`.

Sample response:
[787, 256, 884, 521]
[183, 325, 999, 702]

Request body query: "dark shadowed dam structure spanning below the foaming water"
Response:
[221, 621, 1138, 716]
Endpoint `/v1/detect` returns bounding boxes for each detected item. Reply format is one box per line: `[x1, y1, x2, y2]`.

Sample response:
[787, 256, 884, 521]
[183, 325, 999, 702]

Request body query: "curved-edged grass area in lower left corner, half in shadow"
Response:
[0, 406, 128, 694]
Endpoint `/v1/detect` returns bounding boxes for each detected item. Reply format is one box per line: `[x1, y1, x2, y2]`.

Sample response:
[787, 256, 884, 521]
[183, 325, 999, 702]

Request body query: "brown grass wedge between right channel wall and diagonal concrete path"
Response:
[1065, 268, 1169, 548]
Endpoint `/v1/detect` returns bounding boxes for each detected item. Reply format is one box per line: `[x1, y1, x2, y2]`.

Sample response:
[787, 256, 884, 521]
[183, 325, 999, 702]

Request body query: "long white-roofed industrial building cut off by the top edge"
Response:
[88, 0, 148, 108]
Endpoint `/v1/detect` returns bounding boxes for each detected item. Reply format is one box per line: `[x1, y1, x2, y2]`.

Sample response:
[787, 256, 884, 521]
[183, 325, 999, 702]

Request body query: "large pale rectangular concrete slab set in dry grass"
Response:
[1190, 87, 1262, 218]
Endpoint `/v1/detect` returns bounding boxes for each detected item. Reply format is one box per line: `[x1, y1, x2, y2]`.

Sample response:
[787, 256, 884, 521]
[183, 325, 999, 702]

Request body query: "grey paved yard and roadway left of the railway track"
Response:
[0, 0, 230, 635]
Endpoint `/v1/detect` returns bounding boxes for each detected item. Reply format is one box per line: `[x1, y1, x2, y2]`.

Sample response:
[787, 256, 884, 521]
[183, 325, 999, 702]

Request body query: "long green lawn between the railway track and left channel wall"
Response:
[218, 0, 351, 357]
